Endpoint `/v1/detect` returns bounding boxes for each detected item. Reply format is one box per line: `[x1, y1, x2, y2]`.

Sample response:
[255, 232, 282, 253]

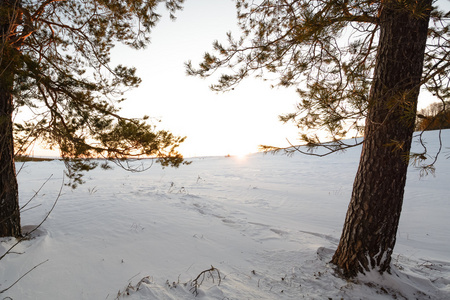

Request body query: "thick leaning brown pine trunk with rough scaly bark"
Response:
[332, 0, 432, 277]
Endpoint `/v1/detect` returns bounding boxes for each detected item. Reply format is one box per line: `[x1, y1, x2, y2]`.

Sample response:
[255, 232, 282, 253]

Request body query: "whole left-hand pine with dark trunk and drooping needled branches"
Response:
[0, 0, 184, 237]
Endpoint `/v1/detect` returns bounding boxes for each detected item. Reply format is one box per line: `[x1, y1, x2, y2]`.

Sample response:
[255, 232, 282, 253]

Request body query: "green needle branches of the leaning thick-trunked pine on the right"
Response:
[186, 0, 450, 158]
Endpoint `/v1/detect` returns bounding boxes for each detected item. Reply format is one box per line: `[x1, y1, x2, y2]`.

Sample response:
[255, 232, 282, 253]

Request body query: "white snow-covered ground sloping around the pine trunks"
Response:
[0, 130, 450, 300]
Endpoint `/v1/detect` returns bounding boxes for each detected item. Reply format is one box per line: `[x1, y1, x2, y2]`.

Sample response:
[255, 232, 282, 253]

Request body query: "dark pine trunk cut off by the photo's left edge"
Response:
[0, 0, 21, 237]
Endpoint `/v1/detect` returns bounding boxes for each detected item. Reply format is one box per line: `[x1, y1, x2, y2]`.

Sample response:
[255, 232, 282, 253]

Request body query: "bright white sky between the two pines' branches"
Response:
[36, 0, 442, 157]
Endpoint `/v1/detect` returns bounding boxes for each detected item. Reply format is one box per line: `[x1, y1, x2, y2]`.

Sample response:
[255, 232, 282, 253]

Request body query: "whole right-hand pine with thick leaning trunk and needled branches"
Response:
[186, 0, 450, 277]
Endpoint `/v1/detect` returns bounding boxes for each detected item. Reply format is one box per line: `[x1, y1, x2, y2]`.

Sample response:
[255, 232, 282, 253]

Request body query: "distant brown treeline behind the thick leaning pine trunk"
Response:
[416, 102, 450, 131]
